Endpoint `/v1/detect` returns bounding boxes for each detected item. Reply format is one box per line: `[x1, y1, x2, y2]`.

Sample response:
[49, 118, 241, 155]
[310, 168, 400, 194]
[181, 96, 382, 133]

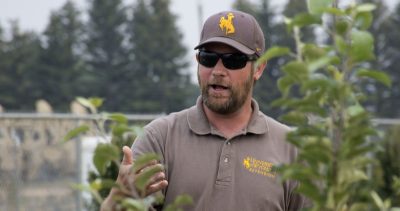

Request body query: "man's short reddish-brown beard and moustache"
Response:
[199, 71, 254, 114]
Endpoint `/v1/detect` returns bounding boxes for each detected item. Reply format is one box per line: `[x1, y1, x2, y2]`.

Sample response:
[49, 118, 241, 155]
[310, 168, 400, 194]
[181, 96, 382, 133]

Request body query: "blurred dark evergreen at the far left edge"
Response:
[0, 21, 40, 111]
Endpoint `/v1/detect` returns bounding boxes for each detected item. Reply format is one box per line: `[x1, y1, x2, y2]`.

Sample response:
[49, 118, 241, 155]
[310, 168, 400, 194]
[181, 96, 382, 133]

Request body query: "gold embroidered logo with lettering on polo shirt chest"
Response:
[243, 156, 276, 178]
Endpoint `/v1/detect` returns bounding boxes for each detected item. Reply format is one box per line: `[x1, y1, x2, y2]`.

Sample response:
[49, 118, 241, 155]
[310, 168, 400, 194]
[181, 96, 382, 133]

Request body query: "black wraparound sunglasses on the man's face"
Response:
[197, 50, 257, 70]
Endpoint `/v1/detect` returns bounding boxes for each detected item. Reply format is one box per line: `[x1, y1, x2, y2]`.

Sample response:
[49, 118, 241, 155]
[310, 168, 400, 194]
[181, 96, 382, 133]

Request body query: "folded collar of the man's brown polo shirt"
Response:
[187, 96, 268, 135]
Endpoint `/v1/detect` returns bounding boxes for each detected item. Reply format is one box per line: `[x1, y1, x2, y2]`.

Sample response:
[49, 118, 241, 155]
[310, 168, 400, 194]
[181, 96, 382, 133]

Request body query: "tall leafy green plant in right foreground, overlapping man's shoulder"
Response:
[261, 0, 391, 211]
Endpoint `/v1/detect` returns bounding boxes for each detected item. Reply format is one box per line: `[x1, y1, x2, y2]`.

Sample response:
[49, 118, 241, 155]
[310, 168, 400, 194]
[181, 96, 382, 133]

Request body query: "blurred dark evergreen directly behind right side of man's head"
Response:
[233, 0, 314, 117]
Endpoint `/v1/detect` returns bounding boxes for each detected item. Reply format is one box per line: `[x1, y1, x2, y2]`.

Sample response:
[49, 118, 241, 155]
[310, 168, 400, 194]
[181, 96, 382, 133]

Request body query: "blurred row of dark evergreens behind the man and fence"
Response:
[0, 0, 400, 118]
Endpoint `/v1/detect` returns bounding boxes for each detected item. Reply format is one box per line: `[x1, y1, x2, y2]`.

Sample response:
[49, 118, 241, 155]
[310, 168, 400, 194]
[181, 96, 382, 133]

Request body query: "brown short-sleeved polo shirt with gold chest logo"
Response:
[132, 98, 304, 211]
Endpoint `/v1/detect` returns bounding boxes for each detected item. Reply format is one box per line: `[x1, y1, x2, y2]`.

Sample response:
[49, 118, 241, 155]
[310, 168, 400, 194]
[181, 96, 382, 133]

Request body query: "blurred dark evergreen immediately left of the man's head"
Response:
[129, 0, 195, 113]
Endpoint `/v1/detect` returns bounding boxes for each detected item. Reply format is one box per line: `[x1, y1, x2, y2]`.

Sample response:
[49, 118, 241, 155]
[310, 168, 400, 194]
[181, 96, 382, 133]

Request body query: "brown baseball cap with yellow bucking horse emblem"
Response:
[194, 11, 265, 56]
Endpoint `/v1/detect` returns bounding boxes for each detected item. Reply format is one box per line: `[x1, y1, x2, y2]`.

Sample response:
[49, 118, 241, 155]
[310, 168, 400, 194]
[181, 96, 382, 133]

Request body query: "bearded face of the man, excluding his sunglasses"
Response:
[197, 43, 254, 114]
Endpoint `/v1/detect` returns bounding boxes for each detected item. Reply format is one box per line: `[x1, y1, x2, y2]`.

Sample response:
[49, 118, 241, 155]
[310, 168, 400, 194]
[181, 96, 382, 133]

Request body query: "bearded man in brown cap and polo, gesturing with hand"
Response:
[102, 11, 304, 211]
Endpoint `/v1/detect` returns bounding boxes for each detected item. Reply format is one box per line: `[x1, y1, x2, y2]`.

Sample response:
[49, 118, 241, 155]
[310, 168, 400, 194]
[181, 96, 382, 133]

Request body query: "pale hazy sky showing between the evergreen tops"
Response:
[0, 0, 399, 78]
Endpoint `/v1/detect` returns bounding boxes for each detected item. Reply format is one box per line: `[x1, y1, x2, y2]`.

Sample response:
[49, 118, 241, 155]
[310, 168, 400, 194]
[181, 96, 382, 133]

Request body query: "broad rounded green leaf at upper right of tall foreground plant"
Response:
[350, 30, 375, 62]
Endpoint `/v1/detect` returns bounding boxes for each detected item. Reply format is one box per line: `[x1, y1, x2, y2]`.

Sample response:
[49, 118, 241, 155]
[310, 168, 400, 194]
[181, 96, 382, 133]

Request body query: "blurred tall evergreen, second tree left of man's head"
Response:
[86, 0, 133, 111]
